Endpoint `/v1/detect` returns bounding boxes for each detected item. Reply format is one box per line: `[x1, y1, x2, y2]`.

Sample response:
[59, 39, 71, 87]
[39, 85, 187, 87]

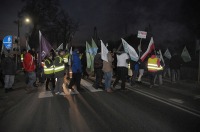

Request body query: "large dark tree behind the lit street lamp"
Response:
[19, 0, 78, 48]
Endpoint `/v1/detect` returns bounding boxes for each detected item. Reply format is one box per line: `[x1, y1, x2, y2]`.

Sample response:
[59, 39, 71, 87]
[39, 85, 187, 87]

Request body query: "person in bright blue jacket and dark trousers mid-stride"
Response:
[68, 49, 82, 91]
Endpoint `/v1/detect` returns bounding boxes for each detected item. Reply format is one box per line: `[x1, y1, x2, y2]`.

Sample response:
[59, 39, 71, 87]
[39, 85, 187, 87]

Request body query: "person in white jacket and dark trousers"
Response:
[113, 52, 129, 90]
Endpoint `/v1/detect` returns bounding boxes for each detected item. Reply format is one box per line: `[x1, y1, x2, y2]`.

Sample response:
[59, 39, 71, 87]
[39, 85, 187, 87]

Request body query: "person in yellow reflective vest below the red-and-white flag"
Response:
[147, 55, 163, 88]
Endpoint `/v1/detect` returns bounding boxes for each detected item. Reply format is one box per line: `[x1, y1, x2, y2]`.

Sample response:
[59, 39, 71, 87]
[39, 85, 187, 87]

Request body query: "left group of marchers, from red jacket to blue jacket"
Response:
[23, 49, 82, 95]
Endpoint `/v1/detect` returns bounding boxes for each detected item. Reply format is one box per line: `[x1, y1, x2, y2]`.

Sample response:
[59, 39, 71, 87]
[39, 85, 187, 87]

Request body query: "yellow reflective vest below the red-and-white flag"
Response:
[147, 58, 163, 72]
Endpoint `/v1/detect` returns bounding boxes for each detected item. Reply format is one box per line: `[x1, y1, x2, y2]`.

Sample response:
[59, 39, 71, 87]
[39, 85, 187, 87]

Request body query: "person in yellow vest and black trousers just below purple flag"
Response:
[44, 55, 55, 91]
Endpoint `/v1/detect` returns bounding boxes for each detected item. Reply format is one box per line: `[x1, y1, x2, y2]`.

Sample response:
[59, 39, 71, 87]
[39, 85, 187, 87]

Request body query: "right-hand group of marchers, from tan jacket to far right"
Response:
[91, 48, 182, 92]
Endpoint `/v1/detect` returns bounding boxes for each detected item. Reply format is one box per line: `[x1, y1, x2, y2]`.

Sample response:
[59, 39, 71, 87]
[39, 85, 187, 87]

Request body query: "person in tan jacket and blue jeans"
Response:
[102, 52, 114, 93]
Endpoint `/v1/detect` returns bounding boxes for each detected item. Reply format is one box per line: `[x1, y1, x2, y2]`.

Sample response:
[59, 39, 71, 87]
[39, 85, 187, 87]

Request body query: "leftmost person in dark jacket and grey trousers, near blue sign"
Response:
[2, 53, 17, 93]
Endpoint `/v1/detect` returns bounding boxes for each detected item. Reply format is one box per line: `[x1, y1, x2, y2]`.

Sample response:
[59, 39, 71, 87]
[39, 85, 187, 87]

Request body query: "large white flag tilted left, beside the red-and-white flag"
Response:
[122, 38, 139, 61]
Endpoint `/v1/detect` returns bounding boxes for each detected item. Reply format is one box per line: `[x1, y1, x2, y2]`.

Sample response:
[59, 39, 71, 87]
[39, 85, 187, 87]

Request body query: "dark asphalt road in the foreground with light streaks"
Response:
[0, 80, 200, 132]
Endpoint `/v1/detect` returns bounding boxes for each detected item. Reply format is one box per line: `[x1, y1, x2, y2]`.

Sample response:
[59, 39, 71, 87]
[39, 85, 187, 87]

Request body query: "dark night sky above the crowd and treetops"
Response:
[0, 0, 194, 47]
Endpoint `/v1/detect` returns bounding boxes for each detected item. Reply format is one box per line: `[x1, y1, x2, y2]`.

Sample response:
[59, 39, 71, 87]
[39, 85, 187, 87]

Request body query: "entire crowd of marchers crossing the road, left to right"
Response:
[0, 44, 184, 94]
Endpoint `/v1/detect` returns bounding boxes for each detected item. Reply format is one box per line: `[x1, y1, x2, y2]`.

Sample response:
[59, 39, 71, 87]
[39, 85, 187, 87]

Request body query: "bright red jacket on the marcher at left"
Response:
[23, 53, 36, 72]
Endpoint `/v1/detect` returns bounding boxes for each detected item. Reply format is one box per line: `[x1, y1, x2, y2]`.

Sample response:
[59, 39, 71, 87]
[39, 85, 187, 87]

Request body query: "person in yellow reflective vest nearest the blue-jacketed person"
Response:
[54, 50, 65, 94]
